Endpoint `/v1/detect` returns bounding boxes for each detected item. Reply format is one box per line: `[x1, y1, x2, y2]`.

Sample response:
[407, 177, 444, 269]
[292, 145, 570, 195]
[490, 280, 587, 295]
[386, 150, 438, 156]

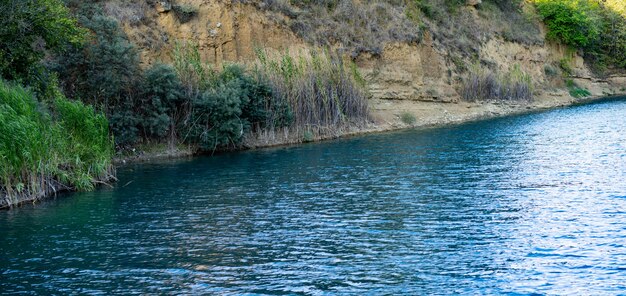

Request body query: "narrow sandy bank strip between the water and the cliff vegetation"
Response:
[114, 90, 626, 165]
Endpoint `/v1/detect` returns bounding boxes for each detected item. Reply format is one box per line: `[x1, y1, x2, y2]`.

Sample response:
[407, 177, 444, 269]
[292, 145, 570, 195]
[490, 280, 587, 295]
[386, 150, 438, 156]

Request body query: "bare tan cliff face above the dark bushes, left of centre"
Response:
[124, 0, 306, 65]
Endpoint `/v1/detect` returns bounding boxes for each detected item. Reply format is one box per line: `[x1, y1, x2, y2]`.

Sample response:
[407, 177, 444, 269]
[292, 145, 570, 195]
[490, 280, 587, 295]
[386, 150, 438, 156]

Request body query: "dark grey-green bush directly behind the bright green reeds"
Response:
[49, 9, 142, 146]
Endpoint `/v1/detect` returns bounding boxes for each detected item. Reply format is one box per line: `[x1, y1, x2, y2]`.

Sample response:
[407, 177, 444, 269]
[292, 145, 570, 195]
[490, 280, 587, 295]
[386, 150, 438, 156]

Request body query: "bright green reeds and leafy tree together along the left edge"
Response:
[0, 0, 113, 207]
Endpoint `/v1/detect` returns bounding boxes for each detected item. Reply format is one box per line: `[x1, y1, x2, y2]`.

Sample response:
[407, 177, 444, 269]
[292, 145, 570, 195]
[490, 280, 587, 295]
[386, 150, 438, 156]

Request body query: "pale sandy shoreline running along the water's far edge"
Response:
[113, 93, 626, 166]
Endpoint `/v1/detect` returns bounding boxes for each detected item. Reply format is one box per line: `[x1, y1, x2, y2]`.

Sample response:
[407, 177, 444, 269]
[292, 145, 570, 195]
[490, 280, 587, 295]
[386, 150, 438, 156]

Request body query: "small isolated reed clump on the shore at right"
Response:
[461, 65, 533, 102]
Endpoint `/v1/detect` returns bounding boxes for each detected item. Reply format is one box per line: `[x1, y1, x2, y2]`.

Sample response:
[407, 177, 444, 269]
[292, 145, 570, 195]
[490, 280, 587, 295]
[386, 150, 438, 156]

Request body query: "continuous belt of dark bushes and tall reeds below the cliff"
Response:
[50, 3, 368, 152]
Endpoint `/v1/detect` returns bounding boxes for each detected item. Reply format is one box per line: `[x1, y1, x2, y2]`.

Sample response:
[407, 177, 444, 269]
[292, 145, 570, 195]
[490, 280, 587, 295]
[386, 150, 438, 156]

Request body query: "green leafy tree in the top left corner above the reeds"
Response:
[0, 0, 86, 91]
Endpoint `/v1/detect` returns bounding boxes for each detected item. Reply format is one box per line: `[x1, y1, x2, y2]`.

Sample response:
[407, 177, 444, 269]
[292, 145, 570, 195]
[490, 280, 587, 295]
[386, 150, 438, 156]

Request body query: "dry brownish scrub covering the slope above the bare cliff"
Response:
[249, 0, 543, 56]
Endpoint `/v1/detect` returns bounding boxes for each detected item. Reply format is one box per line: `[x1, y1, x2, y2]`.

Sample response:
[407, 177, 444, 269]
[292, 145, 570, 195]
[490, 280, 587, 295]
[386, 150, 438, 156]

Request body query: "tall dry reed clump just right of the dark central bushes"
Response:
[255, 50, 369, 138]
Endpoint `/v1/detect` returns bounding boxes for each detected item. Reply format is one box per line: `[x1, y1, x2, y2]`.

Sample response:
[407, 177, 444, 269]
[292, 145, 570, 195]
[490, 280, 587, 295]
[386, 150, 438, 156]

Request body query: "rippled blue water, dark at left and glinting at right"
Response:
[0, 99, 626, 295]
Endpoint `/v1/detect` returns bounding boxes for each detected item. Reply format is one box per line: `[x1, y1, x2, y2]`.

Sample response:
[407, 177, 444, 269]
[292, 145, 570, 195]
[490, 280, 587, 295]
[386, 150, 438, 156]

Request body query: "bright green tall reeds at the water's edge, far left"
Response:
[0, 80, 113, 208]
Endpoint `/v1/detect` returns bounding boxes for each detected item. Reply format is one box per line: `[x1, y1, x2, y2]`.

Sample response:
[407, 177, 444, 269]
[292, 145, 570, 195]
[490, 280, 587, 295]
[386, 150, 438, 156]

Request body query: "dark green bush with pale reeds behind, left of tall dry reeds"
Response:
[173, 44, 290, 151]
